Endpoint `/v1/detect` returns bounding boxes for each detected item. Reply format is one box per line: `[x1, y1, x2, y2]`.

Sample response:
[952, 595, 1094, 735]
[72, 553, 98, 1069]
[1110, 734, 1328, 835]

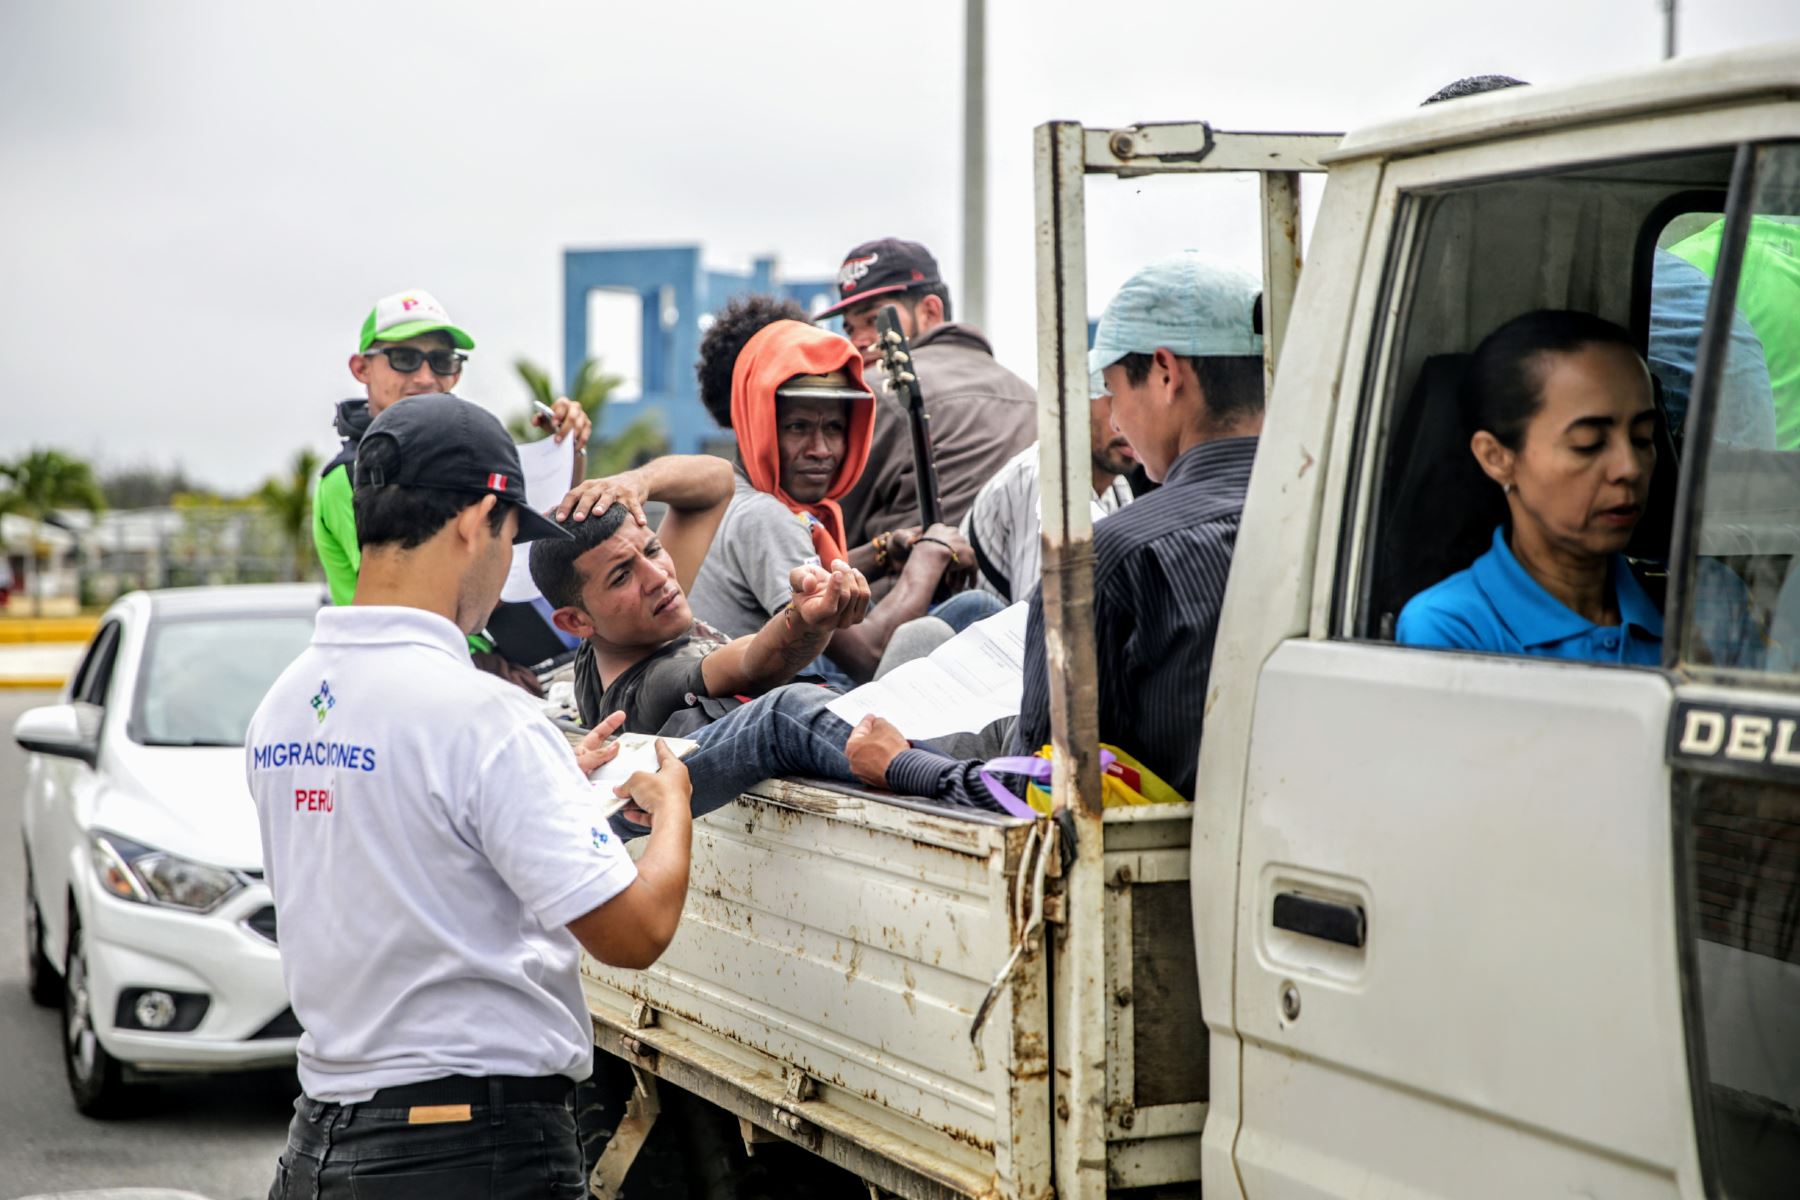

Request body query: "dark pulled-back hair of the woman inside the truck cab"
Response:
[1462, 308, 1638, 450]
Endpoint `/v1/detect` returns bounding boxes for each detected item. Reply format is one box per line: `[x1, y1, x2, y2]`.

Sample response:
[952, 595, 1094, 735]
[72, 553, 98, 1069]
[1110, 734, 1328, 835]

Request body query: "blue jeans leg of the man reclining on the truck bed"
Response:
[684, 684, 857, 817]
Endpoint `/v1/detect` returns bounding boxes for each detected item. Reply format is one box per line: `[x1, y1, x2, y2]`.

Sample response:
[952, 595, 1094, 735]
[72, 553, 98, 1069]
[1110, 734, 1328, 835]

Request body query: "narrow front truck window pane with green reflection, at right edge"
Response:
[1670, 146, 1800, 680]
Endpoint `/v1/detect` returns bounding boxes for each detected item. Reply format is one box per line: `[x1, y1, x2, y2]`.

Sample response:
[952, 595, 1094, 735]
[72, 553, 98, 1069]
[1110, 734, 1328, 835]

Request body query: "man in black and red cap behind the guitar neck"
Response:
[819, 237, 1037, 545]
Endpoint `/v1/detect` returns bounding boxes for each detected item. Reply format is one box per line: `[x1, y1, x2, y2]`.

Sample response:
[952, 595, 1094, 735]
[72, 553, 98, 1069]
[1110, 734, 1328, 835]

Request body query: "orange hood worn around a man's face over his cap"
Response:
[731, 320, 875, 569]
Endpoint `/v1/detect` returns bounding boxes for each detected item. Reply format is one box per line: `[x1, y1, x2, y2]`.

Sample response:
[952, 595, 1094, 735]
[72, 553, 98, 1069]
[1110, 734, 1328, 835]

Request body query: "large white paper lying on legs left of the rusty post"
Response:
[826, 603, 1030, 741]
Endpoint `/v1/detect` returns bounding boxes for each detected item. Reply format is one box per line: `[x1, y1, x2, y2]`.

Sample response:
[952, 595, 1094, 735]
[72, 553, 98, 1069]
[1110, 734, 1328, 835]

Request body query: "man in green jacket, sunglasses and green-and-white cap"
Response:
[313, 290, 592, 691]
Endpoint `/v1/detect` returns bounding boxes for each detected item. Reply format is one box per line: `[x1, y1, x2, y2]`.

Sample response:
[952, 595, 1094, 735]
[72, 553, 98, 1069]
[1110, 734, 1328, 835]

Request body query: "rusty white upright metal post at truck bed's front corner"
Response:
[1035, 121, 1107, 1200]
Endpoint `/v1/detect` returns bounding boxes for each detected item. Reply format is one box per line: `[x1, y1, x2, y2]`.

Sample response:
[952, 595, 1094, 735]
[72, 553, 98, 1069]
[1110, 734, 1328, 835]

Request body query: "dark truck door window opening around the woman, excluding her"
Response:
[1341, 148, 1732, 666]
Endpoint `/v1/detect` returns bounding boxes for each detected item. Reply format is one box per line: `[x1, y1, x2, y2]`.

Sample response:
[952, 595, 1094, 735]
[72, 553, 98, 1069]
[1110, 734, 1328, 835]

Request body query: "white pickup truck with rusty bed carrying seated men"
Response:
[585, 45, 1800, 1200]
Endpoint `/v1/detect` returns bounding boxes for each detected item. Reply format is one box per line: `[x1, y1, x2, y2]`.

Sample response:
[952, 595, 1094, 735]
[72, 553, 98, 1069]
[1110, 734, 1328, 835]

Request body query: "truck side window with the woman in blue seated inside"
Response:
[1339, 148, 1733, 666]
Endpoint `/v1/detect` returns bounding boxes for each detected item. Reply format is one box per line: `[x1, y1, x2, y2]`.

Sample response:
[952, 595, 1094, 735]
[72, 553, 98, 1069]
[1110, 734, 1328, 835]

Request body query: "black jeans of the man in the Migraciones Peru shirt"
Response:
[268, 1096, 587, 1200]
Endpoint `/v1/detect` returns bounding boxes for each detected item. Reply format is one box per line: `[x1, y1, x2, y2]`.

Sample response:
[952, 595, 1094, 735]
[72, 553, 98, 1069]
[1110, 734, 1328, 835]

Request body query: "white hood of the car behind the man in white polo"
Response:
[94, 738, 263, 871]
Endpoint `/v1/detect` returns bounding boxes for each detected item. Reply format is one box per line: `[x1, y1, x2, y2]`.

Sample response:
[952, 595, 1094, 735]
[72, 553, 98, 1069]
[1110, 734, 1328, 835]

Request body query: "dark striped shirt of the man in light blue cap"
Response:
[887, 437, 1256, 808]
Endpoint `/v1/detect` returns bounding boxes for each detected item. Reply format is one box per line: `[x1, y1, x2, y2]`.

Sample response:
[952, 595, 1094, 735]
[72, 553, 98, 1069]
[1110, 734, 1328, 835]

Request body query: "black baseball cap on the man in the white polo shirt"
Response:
[351, 392, 574, 543]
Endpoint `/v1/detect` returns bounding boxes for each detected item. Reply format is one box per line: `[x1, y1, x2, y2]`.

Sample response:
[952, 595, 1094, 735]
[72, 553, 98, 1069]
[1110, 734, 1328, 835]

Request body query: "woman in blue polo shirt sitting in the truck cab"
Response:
[1397, 311, 1663, 666]
